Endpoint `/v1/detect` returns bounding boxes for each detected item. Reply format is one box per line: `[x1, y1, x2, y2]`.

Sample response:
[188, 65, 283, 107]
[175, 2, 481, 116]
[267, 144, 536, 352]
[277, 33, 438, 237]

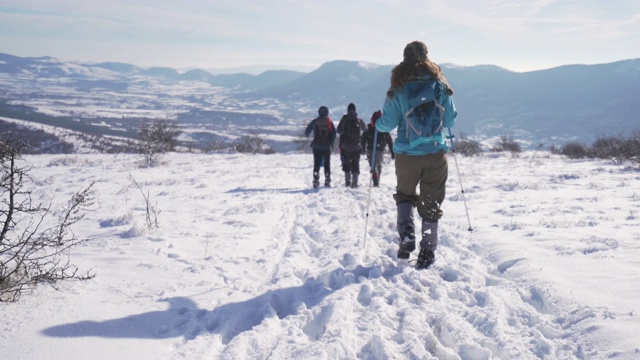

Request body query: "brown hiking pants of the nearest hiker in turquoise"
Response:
[393, 151, 449, 221]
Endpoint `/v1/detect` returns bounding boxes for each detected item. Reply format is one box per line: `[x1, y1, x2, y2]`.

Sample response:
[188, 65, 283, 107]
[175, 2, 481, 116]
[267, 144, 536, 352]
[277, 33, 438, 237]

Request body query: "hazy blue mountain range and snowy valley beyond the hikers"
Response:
[0, 53, 640, 150]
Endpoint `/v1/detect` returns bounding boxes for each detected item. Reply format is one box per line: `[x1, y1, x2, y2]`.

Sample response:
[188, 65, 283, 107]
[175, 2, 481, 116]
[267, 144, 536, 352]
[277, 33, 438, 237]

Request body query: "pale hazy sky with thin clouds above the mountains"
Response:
[0, 0, 640, 71]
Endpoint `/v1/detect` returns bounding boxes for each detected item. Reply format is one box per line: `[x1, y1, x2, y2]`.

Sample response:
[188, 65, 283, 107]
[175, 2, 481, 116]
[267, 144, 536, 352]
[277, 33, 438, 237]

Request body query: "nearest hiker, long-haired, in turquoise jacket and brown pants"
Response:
[376, 41, 457, 269]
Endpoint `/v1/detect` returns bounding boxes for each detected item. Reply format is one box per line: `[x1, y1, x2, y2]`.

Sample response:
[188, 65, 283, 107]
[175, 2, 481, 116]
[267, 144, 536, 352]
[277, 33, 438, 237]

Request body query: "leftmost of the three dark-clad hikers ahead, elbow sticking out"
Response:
[304, 106, 336, 189]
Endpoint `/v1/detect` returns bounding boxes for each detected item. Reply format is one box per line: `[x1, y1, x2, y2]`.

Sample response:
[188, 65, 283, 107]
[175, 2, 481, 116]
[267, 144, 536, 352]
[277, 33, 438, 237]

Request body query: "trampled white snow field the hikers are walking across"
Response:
[0, 152, 640, 360]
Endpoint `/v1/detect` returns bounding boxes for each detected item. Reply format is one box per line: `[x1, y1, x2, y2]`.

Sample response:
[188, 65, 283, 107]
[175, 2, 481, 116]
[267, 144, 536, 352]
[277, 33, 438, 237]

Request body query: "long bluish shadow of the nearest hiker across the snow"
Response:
[42, 266, 379, 344]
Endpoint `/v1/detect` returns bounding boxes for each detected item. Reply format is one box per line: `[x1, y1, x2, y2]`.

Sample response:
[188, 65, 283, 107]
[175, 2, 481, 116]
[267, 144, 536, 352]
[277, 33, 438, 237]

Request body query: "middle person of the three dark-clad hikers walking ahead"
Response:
[338, 103, 367, 188]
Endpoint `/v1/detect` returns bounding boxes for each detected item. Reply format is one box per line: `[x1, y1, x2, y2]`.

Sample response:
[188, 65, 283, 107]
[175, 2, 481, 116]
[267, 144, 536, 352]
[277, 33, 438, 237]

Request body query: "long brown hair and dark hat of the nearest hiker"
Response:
[387, 41, 453, 98]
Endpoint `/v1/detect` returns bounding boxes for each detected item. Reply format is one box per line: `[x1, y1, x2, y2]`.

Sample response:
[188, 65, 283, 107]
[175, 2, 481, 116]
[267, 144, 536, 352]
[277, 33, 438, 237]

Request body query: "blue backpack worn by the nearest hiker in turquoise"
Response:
[403, 79, 444, 146]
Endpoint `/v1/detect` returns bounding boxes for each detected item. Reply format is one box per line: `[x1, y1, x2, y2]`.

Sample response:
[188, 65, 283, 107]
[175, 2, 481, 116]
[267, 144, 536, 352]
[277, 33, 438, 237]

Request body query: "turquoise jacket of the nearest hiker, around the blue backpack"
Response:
[376, 76, 458, 155]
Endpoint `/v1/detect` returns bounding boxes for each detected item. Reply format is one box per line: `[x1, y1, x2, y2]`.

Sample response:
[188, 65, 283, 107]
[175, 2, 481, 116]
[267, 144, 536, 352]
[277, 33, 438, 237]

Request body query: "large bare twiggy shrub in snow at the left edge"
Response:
[0, 134, 95, 302]
